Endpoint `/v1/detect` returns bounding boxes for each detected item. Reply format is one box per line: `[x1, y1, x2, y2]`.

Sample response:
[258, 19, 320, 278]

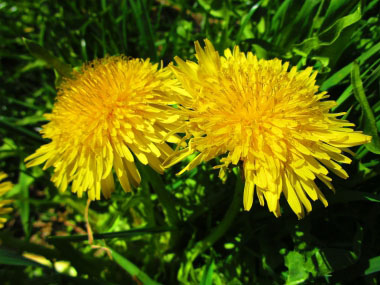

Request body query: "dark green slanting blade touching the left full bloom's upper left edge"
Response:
[23, 38, 72, 77]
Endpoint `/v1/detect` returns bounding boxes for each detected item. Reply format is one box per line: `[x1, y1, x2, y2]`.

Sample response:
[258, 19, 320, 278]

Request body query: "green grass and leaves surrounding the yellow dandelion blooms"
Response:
[0, 0, 380, 284]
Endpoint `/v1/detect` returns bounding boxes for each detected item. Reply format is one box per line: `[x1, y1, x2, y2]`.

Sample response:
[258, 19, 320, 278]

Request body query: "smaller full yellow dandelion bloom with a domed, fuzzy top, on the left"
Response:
[26, 56, 183, 200]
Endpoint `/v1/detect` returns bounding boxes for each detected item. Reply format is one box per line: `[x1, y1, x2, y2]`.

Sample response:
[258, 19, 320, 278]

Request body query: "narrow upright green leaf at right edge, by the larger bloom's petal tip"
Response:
[351, 62, 380, 154]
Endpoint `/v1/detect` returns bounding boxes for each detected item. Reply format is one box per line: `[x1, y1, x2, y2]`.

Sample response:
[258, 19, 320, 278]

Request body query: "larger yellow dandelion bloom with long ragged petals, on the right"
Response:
[165, 40, 371, 218]
